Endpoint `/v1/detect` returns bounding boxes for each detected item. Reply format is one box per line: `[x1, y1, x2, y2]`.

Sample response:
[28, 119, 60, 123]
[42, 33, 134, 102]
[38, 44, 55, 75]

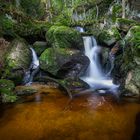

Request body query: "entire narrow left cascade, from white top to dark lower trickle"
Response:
[23, 48, 39, 85]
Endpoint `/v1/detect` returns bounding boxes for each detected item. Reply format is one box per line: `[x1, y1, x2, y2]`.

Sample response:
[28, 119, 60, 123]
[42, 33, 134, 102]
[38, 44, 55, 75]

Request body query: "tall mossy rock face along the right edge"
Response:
[114, 26, 140, 97]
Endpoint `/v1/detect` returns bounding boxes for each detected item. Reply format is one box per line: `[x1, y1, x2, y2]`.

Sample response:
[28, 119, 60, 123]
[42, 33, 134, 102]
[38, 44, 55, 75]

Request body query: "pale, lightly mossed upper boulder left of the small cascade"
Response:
[6, 39, 32, 69]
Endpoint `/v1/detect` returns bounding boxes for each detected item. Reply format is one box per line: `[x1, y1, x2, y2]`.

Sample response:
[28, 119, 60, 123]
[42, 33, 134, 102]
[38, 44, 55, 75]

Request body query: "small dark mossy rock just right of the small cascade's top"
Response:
[33, 41, 47, 56]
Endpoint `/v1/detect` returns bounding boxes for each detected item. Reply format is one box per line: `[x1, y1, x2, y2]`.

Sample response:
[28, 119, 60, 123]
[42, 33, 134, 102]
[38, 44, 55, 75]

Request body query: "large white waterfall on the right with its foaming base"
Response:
[81, 36, 118, 92]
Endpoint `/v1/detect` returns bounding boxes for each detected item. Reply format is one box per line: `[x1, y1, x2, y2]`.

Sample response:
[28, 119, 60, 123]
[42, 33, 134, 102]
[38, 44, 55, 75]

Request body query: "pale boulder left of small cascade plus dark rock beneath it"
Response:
[6, 39, 32, 83]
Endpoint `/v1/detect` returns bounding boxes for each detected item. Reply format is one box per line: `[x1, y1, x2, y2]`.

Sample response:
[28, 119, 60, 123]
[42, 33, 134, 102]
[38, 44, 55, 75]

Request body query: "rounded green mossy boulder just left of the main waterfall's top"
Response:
[46, 25, 84, 50]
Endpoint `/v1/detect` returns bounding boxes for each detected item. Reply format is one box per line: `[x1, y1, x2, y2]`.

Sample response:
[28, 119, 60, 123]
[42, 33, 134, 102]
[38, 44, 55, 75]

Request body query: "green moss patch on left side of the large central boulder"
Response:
[39, 48, 77, 75]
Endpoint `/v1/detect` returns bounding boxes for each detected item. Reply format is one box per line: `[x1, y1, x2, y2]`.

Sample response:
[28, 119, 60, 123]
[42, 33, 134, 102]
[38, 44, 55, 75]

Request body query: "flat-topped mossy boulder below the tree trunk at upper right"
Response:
[116, 18, 140, 32]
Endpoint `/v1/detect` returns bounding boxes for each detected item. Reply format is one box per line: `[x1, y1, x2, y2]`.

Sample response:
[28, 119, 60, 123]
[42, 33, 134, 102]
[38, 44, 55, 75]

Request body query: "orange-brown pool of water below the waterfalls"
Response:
[0, 85, 140, 140]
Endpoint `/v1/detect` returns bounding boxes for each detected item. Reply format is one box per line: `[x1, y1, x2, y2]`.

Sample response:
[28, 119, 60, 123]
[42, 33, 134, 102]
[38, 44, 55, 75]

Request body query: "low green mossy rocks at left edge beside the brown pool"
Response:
[0, 79, 17, 102]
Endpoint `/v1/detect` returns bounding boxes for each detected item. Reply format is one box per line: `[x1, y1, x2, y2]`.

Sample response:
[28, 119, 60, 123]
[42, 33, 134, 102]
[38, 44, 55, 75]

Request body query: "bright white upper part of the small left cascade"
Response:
[30, 48, 39, 69]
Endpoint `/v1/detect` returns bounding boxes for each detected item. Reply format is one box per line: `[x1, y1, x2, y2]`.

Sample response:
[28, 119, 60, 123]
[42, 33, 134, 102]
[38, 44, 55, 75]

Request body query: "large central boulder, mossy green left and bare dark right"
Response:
[40, 48, 89, 78]
